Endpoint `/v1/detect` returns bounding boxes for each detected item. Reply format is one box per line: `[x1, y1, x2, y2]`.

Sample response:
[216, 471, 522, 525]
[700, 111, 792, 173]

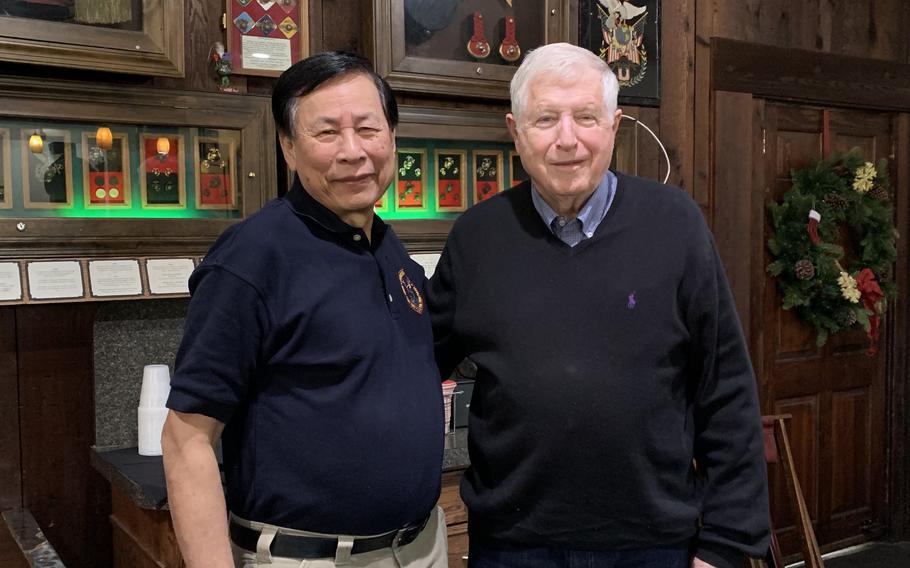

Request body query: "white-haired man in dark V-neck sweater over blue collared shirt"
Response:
[428, 44, 770, 568]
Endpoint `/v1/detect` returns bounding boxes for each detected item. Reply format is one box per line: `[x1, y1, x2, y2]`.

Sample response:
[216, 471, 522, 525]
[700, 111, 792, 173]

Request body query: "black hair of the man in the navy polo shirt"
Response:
[272, 51, 398, 138]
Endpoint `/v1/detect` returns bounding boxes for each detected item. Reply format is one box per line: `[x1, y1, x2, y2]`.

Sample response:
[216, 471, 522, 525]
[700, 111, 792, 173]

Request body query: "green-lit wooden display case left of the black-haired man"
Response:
[0, 79, 276, 259]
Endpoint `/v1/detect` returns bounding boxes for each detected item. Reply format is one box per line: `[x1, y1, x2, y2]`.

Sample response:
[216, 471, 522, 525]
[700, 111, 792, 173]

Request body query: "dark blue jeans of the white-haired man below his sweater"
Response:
[468, 542, 690, 568]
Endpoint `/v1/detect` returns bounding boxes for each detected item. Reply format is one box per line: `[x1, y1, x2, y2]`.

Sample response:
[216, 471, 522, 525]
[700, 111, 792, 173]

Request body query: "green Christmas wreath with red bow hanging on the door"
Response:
[768, 150, 898, 356]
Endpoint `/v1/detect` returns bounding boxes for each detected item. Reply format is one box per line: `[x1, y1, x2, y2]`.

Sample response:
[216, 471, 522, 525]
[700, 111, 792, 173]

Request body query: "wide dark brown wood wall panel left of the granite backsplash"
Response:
[16, 303, 111, 567]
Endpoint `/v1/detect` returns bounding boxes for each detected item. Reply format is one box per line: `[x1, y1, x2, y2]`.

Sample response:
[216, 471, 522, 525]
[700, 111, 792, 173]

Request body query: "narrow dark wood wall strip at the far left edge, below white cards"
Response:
[0, 307, 22, 508]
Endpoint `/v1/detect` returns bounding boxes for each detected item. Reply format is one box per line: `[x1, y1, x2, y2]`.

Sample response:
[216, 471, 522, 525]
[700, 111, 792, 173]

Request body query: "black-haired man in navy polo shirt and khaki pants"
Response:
[162, 53, 446, 568]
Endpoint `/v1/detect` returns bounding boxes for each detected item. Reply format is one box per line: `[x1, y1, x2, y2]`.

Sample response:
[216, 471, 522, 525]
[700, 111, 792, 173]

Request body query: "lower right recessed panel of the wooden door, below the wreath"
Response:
[830, 388, 873, 516]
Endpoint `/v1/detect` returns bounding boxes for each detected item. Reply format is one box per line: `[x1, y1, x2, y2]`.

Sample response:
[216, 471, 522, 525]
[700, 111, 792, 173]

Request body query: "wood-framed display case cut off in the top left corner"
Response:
[0, 0, 184, 77]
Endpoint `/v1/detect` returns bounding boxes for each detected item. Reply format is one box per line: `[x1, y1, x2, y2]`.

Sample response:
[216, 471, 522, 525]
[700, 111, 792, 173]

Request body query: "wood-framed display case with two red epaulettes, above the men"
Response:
[373, 0, 578, 99]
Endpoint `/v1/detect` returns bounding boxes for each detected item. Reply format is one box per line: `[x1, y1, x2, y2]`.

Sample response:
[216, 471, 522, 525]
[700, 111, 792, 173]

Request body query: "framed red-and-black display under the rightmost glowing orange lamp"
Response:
[139, 132, 186, 209]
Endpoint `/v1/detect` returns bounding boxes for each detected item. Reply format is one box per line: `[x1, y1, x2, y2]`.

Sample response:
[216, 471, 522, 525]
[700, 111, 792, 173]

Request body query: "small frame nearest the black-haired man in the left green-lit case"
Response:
[193, 136, 237, 210]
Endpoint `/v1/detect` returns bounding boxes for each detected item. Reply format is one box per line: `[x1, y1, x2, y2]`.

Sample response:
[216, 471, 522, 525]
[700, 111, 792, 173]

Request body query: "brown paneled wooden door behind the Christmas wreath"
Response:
[753, 103, 896, 553]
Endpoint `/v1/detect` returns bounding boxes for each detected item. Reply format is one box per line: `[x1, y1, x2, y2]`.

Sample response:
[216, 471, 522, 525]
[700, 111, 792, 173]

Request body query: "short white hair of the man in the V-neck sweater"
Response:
[509, 43, 619, 121]
